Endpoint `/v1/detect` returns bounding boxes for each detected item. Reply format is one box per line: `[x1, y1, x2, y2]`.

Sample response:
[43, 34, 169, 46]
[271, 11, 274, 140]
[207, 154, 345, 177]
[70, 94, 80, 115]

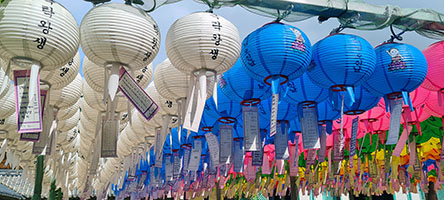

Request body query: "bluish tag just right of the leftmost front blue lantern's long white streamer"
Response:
[274, 121, 290, 160]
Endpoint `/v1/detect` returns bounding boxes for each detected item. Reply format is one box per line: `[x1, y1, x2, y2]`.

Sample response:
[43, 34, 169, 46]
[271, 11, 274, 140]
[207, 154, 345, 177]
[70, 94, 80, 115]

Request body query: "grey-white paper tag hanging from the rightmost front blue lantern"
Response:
[386, 98, 403, 145]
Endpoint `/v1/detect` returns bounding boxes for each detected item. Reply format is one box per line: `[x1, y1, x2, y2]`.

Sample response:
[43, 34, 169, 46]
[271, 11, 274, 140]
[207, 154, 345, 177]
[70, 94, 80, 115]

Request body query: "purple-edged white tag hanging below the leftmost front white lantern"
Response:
[14, 70, 43, 133]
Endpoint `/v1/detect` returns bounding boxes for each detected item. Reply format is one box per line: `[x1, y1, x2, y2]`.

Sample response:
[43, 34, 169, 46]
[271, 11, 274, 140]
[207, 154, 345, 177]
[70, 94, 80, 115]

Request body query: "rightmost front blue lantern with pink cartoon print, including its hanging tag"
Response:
[363, 42, 427, 144]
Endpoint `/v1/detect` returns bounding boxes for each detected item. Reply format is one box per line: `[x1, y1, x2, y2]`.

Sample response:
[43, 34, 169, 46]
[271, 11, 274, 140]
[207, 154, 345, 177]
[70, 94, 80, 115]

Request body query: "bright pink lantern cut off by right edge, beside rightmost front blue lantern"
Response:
[421, 41, 444, 91]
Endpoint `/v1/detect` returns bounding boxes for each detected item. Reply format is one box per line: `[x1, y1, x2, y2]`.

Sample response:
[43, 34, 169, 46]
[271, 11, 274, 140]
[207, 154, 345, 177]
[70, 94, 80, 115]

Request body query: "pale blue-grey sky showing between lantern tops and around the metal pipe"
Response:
[56, 0, 444, 75]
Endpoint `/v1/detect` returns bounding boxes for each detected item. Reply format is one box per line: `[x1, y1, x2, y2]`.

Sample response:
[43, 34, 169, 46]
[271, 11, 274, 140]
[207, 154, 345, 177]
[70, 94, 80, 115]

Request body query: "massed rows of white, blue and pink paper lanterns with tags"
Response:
[0, 0, 444, 197]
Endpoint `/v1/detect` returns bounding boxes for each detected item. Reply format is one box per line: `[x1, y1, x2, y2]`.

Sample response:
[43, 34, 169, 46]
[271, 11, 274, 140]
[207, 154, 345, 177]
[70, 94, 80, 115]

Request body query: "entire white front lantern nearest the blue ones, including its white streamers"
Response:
[165, 12, 241, 132]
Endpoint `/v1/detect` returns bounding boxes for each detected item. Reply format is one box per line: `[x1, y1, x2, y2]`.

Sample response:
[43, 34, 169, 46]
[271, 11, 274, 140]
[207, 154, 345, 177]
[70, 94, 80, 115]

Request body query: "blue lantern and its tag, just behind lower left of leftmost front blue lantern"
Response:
[217, 59, 271, 151]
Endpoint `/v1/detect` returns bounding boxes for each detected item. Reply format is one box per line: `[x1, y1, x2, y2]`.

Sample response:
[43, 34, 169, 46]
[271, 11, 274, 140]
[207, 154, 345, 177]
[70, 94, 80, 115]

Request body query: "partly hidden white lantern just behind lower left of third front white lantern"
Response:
[154, 59, 188, 100]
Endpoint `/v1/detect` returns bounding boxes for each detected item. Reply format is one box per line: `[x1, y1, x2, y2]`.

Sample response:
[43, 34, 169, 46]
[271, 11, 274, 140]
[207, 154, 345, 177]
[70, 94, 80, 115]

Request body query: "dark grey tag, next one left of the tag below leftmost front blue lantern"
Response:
[219, 125, 233, 163]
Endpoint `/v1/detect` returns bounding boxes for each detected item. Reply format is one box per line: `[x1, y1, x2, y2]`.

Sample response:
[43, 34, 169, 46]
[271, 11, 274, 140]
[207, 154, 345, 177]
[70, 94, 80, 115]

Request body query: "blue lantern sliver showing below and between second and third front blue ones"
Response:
[329, 86, 381, 115]
